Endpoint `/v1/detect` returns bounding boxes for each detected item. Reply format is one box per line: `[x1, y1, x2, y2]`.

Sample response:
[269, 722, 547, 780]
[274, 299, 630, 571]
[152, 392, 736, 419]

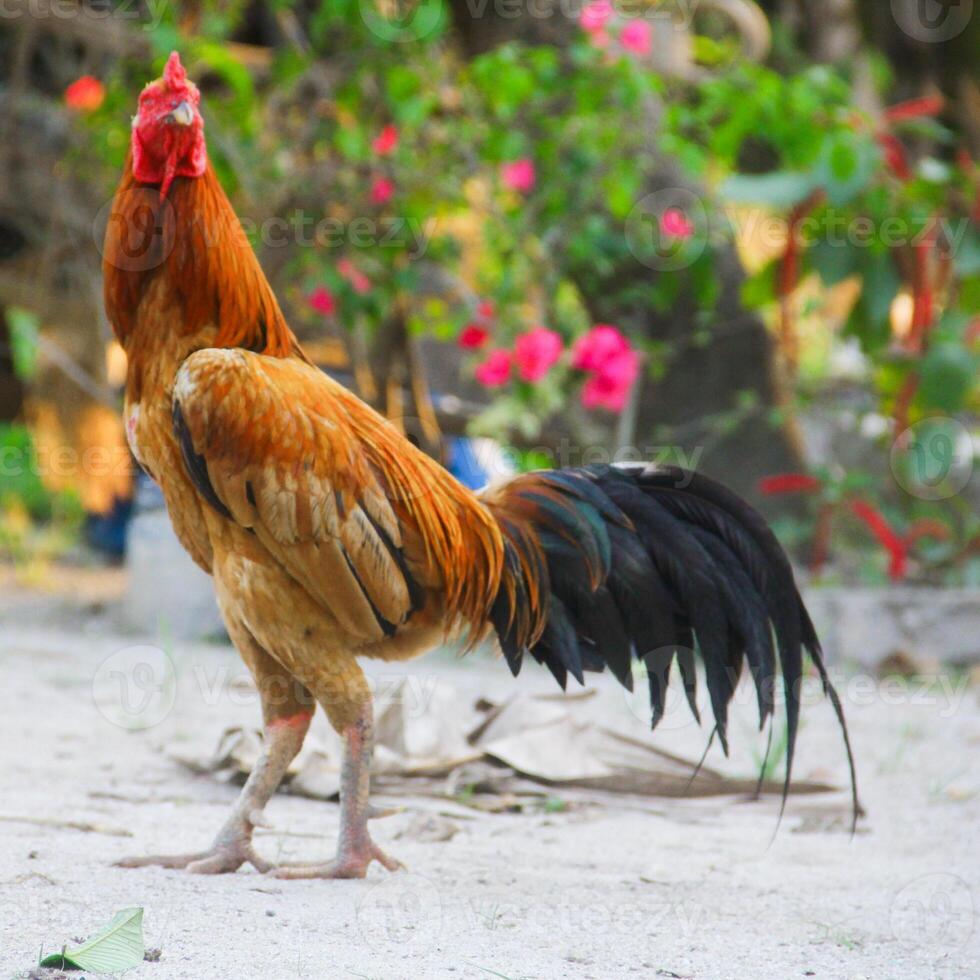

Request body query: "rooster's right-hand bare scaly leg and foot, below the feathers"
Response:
[272, 699, 403, 878]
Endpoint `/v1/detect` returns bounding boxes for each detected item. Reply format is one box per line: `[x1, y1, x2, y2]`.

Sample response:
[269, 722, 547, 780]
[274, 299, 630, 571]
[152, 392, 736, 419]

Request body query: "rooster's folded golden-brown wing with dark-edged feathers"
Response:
[173, 349, 424, 642]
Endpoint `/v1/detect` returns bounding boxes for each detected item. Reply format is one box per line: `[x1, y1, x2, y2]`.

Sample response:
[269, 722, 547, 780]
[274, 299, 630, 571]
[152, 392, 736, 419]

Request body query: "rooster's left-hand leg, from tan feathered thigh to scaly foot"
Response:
[117, 624, 313, 874]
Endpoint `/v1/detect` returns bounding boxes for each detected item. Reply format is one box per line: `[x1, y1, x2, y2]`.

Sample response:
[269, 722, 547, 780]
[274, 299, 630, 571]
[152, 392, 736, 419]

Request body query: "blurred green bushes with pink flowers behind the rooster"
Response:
[11, 0, 980, 580]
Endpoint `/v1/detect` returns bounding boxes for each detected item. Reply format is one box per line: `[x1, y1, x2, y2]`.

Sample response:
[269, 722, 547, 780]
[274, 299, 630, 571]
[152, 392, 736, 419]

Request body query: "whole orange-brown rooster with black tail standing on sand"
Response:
[104, 52, 856, 878]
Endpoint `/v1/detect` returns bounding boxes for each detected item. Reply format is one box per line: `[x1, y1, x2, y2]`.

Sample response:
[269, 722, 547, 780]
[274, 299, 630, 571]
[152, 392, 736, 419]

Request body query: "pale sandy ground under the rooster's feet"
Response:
[0, 568, 980, 980]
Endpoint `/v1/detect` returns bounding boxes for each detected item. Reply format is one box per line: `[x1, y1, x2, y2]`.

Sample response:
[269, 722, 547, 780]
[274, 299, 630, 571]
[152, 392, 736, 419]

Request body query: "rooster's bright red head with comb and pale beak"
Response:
[132, 51, 208, 198]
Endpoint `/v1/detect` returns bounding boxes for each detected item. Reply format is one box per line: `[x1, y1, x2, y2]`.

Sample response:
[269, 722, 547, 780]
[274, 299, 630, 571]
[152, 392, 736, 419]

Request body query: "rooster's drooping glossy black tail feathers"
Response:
[487, 466, 859, 820]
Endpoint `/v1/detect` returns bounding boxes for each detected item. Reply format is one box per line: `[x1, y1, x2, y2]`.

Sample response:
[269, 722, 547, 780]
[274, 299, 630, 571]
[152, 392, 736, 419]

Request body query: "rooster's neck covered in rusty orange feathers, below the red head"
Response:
[103, 161, 303, 394]
